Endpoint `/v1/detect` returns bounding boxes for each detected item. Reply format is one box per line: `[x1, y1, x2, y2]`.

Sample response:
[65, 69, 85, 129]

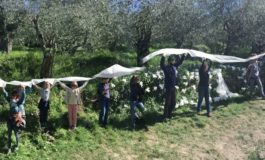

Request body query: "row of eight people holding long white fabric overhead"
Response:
[3, 54, 264, 152]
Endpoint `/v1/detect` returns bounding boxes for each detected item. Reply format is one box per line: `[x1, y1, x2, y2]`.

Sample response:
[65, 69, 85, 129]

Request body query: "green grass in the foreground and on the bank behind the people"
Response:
[0, 50, 265, 160]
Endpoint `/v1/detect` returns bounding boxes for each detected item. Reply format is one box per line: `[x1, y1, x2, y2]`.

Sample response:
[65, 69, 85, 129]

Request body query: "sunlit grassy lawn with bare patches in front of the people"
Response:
[0, 100, 265, 160]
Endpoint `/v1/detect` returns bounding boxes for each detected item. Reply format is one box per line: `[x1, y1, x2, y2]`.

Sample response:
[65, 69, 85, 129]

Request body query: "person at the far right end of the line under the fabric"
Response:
[246, 53, 265, 98]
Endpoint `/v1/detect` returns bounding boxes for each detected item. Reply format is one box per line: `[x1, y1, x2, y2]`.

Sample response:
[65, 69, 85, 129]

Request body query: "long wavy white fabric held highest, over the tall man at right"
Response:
[142, 48, 265, 63]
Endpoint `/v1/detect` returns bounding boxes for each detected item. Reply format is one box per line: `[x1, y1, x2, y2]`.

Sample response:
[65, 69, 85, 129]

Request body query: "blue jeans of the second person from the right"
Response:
[197, 86, 211, 113]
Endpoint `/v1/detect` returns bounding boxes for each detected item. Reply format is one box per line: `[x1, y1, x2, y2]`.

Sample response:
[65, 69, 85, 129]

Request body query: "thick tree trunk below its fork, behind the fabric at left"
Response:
[40, 52, 54, 78]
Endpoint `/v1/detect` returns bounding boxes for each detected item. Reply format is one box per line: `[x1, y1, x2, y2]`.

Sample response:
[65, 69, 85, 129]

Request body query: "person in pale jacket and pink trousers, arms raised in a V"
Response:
[58, 81, 88, 131]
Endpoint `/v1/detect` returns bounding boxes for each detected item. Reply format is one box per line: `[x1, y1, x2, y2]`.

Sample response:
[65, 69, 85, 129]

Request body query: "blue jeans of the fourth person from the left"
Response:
[99, 98, 109, 125]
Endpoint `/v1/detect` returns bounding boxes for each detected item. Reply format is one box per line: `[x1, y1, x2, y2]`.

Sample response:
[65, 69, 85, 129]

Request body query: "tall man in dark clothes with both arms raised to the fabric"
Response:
[160, 54, 186, 119]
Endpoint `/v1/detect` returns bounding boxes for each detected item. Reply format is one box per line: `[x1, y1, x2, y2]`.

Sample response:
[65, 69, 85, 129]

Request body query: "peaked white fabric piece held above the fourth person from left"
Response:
[93, 64, 144, 78]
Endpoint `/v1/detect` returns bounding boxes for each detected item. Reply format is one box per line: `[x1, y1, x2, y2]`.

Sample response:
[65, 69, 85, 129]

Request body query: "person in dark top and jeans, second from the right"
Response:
[197, 60, 212, 117]
